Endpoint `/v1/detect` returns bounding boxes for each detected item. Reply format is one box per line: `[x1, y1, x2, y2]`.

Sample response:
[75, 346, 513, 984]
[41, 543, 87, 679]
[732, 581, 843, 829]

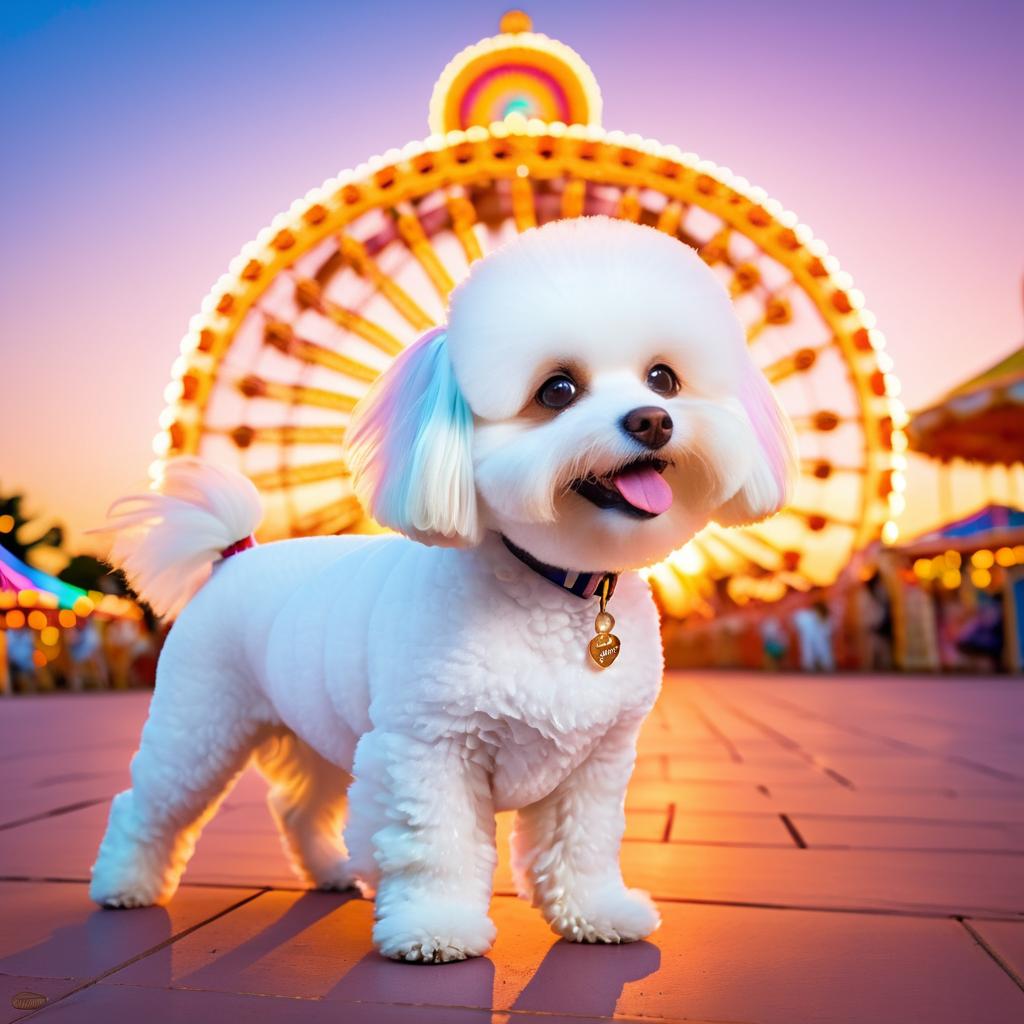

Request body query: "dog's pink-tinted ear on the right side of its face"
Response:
[712, 359, 797, 526]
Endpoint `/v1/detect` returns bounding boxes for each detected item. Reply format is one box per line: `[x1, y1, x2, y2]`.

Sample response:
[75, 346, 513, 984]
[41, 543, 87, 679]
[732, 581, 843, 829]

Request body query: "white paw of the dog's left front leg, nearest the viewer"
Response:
[374, 900, 496, 964]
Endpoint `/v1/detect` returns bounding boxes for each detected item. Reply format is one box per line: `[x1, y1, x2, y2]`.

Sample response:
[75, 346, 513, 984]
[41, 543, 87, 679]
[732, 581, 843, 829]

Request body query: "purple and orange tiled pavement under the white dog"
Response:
[0, 674, 1024, 1024]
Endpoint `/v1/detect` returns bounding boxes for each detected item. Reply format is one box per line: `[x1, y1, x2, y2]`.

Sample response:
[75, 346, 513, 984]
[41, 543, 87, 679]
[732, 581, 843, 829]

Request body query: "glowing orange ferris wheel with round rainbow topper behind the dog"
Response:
[155, 11, 906, 615]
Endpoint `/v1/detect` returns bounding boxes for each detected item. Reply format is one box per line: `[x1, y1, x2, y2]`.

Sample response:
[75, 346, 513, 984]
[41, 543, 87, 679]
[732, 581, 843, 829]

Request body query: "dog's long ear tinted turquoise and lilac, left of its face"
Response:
[346, 329, 479, 547]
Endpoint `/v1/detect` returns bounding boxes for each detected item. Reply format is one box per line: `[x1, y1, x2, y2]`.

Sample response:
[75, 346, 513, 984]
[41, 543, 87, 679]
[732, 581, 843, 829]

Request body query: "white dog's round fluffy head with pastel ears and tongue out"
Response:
[348, 217, 795, 570]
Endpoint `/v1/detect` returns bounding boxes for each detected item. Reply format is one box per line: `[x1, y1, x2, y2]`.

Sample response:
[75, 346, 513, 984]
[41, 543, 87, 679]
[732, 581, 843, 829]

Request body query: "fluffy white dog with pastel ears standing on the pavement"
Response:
[91, 217, 795, 963]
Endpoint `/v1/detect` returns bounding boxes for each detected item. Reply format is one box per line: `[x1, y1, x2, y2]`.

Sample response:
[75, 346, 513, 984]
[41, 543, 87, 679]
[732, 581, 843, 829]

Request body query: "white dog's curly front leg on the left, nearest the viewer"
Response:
[345, 730, 497, 964]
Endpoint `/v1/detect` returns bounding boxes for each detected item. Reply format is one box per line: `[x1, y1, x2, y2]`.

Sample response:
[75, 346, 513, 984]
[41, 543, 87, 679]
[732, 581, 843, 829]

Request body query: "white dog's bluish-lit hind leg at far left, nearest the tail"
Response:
[89, 667, 266, 907]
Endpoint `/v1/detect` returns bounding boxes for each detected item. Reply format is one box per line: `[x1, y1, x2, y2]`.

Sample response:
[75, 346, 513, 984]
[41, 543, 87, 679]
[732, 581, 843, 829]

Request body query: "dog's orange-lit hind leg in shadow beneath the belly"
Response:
[255, 728, 352, 889]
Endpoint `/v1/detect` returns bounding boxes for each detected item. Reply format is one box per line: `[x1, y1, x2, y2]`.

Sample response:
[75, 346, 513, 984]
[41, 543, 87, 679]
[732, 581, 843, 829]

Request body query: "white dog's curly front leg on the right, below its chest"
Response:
[512, 720, 660, 942]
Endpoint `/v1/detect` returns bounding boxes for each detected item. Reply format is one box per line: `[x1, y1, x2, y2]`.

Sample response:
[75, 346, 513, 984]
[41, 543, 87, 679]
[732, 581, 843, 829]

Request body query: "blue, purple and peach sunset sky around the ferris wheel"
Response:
[0, 0, 1024, 548]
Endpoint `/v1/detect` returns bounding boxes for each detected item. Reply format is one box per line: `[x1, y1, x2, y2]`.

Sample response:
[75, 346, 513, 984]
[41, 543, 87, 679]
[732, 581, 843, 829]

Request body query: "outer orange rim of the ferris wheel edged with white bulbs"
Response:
[155, 117, 905, 547]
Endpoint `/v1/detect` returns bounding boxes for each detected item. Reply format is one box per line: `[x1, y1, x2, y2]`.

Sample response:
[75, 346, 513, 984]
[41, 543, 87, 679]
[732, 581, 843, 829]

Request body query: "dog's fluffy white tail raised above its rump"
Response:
[92, 456, 263, 616]
